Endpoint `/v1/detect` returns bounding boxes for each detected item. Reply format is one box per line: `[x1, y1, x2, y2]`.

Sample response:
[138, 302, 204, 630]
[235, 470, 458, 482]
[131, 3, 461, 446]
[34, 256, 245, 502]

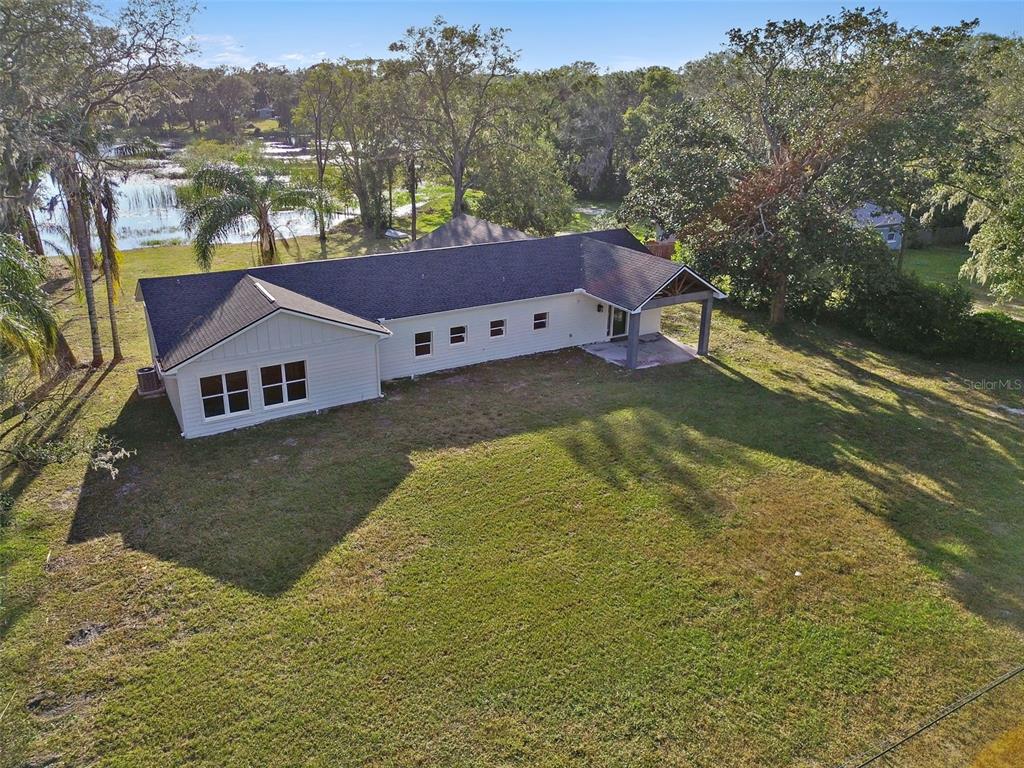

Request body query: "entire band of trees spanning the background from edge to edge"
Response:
[0, 0, 1024, 376]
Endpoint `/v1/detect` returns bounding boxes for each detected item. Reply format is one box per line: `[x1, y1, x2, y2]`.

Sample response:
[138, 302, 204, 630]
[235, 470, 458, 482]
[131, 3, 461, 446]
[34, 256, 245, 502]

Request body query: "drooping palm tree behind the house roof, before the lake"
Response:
[182, 164, 315, 269]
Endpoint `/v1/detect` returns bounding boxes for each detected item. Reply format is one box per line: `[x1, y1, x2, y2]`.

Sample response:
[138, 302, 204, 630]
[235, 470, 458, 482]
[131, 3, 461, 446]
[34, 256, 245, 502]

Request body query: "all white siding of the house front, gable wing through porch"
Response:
[149, 294, 662, 437]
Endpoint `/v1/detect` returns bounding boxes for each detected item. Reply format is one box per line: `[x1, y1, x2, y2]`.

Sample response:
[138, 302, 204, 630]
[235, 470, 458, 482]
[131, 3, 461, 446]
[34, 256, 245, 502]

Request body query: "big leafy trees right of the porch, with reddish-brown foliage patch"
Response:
[618, 10, 1024, 330]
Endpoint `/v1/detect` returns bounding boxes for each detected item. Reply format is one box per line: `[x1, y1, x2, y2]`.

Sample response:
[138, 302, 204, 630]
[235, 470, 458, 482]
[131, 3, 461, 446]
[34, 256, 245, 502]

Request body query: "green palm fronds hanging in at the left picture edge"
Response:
[0, 234, 58, 370]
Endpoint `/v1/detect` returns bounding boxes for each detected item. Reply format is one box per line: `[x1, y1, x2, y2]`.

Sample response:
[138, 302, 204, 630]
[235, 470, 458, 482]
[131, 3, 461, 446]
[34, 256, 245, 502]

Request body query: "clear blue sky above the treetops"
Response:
[184, 0, 1024, 70]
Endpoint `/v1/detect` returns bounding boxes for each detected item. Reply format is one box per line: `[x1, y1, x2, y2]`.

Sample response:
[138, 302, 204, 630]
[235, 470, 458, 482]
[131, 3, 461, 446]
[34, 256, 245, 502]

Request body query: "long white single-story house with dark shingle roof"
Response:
[135, 224, 724, 437]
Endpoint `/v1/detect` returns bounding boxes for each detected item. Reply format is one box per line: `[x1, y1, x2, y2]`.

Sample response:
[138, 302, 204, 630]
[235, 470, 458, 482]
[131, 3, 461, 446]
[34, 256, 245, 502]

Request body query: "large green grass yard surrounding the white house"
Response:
[0, 236, 1024, 768]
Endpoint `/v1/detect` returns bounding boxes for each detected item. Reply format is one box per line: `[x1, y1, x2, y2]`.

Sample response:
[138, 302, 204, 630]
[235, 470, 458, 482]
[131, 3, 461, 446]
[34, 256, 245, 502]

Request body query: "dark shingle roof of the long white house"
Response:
[138, 229, 716, 371]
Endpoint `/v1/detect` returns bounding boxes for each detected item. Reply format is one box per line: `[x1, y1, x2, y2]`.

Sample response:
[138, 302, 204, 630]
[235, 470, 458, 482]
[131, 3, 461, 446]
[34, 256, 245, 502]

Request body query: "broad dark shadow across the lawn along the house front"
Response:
[70, 339, 1024, 629]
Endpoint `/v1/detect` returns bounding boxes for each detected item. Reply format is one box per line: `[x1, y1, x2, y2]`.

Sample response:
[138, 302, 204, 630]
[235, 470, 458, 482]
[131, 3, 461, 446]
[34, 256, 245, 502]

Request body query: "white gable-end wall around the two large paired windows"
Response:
[165, 313, 380, 437]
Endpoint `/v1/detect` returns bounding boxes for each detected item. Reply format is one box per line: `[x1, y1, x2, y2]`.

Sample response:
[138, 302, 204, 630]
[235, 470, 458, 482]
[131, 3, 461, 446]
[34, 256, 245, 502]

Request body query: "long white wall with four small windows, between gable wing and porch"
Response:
[380, 293, 660, 381]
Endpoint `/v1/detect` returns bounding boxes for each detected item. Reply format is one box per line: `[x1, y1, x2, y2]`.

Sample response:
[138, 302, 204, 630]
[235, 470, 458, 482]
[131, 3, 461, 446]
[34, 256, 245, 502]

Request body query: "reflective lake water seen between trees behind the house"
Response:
[36, 142, 357, 255]
